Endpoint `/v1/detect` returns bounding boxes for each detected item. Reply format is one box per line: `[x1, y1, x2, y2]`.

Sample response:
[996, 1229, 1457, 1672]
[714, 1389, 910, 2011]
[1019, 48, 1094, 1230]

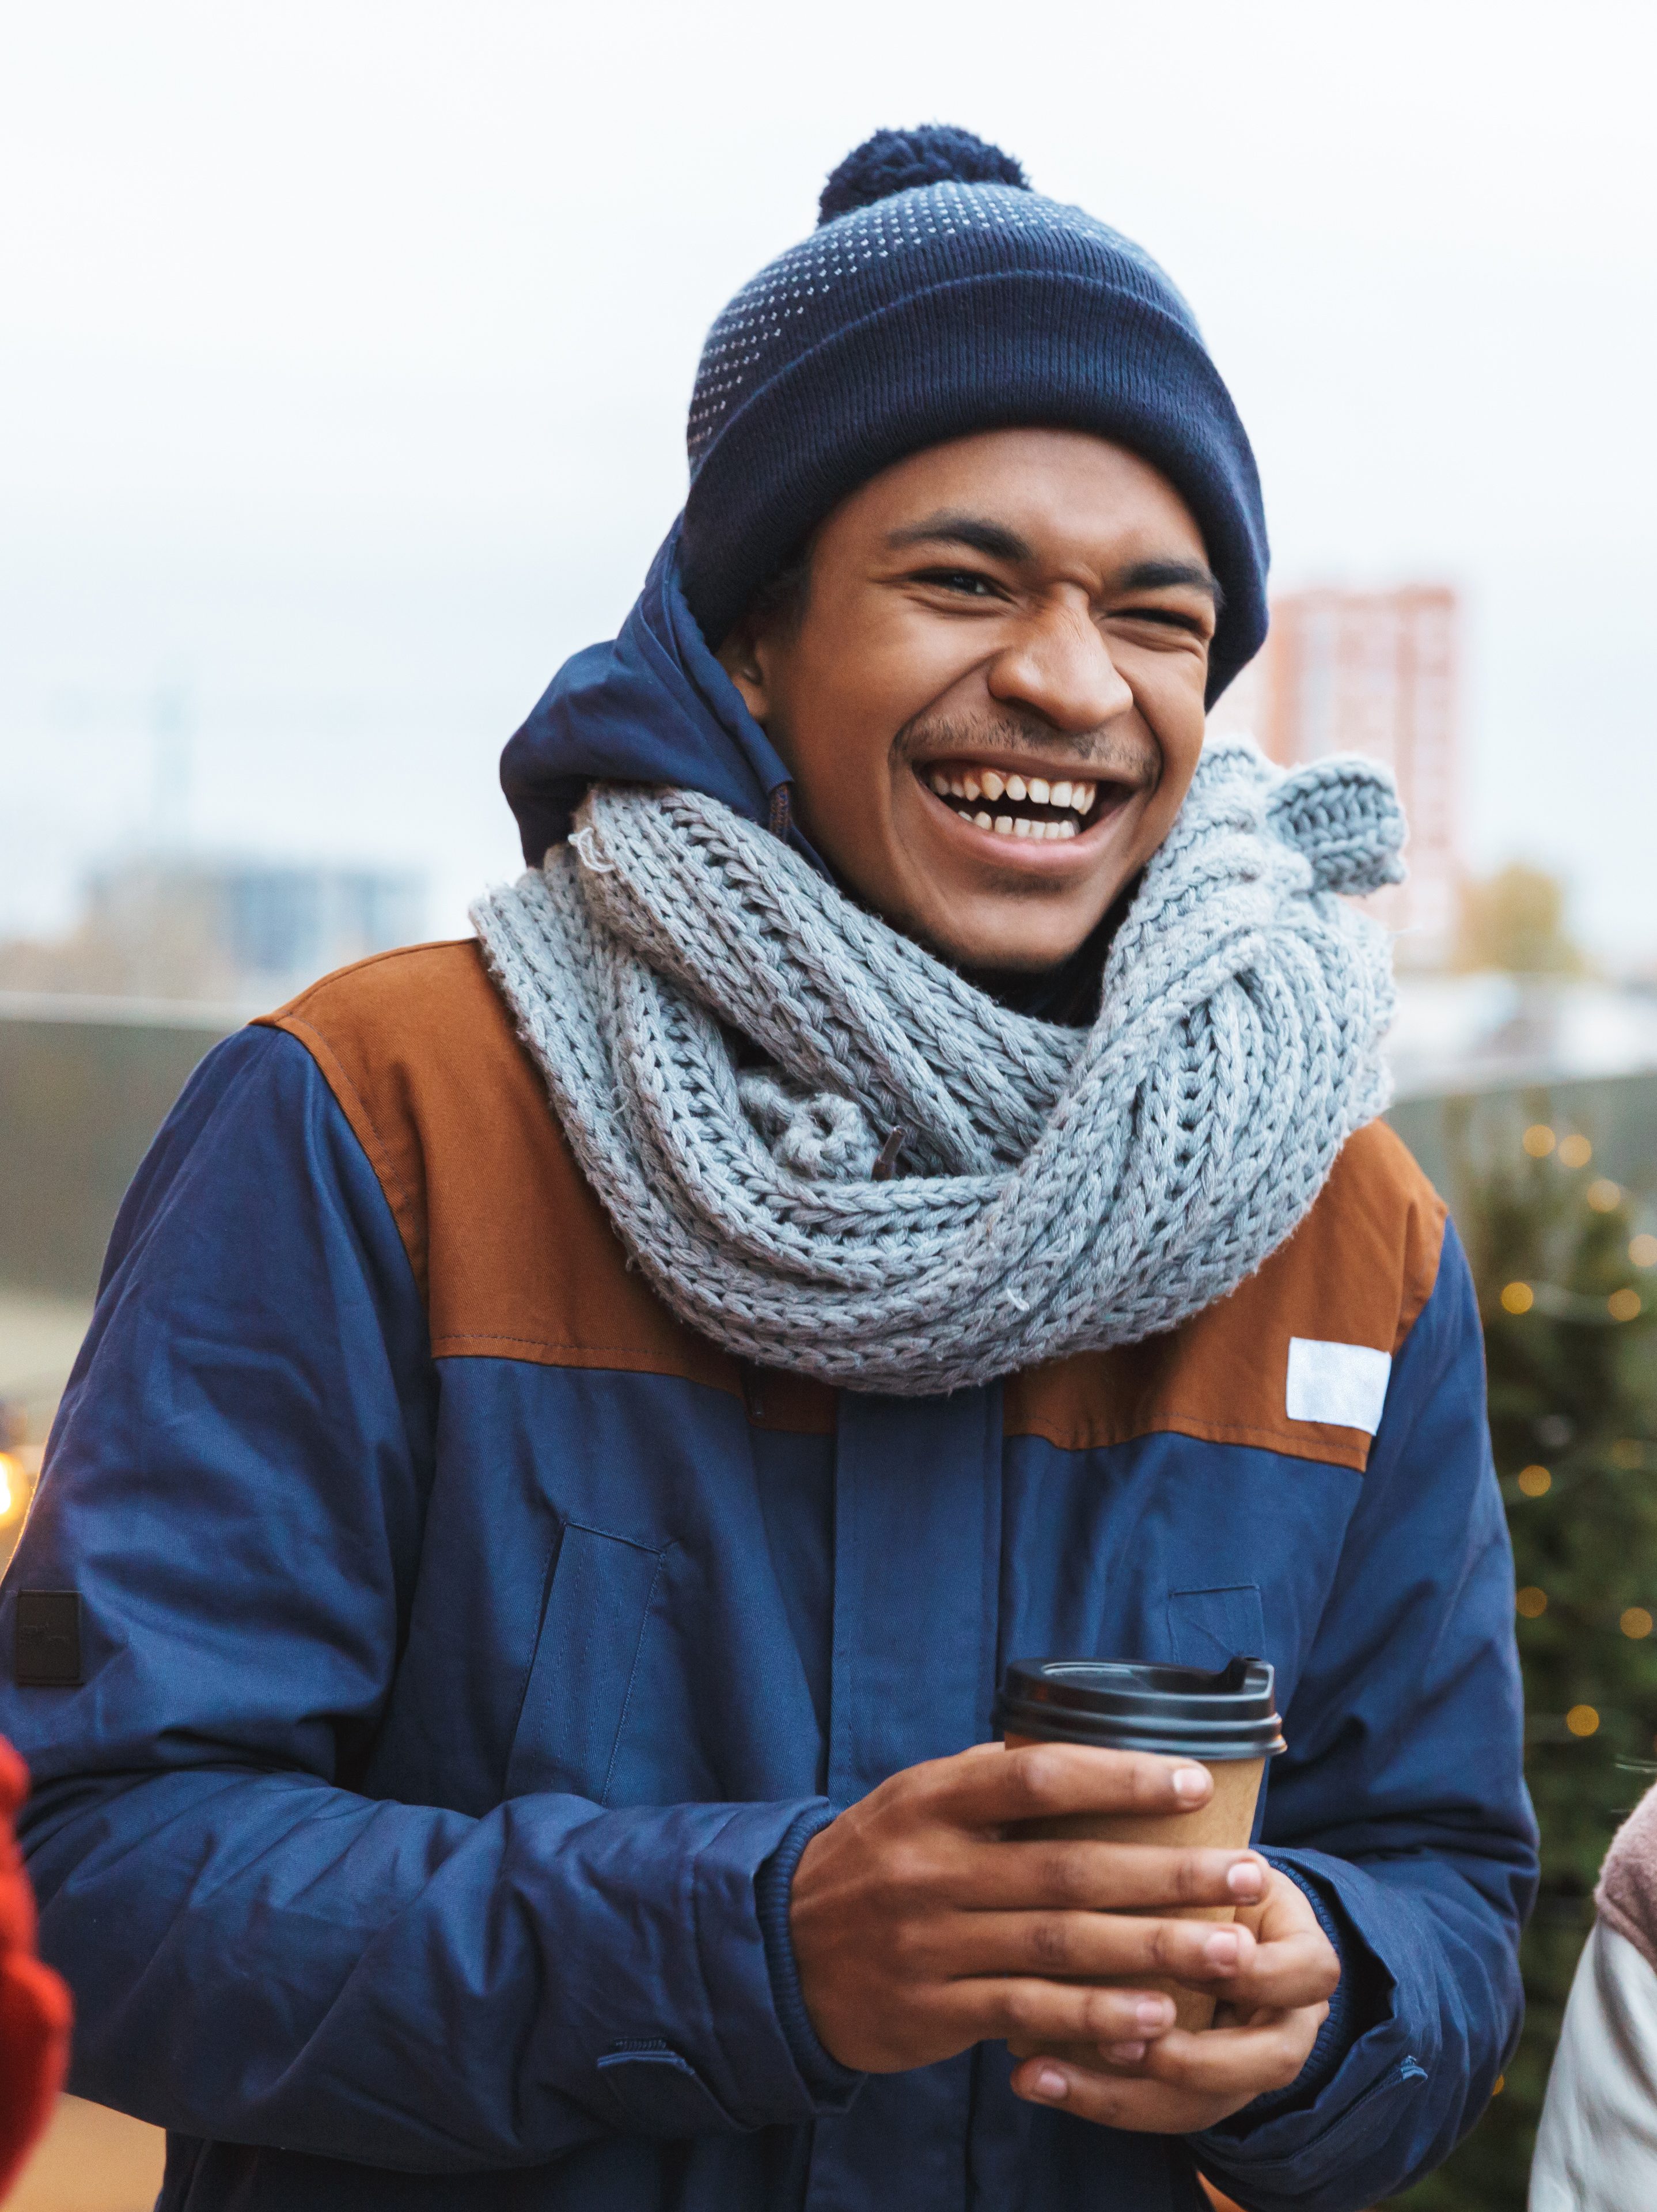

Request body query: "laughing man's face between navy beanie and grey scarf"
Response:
[719, 429, 1217, 971]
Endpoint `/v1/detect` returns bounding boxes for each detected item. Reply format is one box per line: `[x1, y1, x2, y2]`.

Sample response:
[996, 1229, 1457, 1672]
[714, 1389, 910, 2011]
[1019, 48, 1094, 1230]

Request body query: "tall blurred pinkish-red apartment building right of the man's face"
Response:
[1217, 584, 1460, 967]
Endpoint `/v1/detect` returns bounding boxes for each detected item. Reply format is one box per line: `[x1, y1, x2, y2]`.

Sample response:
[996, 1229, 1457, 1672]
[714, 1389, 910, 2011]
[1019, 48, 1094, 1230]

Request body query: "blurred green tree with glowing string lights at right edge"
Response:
[1394, 1095, 1657, 2212]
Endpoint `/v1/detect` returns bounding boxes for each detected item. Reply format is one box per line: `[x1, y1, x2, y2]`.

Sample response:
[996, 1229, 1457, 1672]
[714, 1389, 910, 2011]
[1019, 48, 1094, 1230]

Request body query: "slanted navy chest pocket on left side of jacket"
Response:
[505, 1522, 673, 1805]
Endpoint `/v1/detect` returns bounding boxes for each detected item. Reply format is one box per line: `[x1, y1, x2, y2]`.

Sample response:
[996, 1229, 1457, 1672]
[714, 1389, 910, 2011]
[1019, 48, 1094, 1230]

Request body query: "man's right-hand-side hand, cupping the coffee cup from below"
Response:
[1013, 1867, 1341, 2135]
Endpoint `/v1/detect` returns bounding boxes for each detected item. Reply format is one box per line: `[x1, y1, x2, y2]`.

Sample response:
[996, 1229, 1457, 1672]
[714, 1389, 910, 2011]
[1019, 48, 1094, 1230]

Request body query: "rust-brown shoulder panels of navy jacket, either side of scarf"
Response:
[263, 940, 1444, 1469]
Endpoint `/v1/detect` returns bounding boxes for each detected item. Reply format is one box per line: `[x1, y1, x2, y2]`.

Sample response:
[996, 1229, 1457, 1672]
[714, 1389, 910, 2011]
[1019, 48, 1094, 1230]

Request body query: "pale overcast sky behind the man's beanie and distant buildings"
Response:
[0, 0, 1657, 956]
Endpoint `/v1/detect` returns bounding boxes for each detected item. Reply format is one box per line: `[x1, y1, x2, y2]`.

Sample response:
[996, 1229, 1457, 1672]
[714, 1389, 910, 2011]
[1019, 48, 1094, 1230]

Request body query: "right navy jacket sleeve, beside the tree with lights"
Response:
[1190, 1228, 1535, 2212]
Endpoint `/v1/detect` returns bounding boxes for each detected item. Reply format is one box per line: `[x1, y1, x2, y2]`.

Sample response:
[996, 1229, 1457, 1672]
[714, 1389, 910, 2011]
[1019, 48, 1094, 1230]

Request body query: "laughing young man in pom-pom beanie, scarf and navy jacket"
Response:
[0, 131, 1533, 2212]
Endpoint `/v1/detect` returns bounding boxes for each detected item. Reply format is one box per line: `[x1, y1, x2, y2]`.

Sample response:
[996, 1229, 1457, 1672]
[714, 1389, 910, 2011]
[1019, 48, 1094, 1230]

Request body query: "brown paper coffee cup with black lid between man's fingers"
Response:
[996, 1659, 1286, 2035]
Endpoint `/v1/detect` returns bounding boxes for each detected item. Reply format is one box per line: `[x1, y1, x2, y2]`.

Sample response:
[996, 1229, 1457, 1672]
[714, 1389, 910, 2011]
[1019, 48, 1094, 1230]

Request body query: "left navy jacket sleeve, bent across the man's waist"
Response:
[0, 1029, 856, 2172]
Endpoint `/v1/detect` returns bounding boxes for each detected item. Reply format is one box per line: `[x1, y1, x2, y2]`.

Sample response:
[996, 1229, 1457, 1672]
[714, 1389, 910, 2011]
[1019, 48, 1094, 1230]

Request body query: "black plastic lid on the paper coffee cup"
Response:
[996, 1659, 1286, 1761]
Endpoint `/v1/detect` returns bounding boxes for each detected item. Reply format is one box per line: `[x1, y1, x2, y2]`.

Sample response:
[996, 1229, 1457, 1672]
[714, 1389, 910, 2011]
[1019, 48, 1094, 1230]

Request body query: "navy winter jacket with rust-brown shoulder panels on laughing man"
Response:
[0, 539, 1535, 2212]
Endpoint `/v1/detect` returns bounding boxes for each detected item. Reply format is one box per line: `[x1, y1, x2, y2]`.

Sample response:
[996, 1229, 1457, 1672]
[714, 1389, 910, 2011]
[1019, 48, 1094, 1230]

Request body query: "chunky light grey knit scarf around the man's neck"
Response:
[473, 741, 1405, 1396]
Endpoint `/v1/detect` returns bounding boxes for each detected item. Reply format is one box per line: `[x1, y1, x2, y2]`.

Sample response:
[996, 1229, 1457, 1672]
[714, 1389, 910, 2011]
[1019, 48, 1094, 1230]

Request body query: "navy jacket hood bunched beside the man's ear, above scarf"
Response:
[500, 522, 790, 867]
